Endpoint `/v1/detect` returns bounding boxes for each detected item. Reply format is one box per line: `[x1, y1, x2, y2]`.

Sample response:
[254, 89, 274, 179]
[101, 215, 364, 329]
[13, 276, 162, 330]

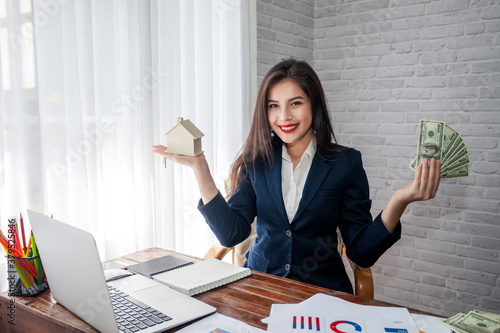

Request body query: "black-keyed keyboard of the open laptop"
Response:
[108, 286, 172, 333]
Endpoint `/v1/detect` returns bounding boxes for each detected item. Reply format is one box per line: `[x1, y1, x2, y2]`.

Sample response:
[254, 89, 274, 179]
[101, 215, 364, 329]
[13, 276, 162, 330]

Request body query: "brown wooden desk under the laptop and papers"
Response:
[0, 248, 430, 333]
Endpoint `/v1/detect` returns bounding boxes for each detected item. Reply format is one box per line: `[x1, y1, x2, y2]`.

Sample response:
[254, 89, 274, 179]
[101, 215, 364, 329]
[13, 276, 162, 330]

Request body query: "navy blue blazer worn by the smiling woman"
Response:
[198, 144, 401, 293]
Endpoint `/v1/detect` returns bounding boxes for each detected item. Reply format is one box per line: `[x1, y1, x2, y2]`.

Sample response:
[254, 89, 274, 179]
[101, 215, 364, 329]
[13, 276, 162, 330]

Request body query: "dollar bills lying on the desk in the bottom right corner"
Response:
[443, 310, 500, 333]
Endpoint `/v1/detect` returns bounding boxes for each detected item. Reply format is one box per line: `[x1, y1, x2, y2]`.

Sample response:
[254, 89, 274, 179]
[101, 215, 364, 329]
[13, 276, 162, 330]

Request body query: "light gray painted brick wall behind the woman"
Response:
[257, 0, 500, 316]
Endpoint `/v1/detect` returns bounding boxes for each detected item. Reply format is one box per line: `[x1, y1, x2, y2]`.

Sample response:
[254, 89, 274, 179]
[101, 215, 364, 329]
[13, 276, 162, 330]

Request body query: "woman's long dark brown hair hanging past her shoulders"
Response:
[226, 58, 343, 197]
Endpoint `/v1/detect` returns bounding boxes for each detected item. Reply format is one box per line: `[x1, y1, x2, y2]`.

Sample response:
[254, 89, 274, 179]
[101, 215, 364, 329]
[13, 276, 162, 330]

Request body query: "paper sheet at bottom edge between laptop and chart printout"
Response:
[178, 313, 265, 333]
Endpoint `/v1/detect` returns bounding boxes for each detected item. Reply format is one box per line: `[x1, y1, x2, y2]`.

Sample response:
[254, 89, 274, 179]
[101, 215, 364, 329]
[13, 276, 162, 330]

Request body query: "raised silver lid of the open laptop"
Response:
[28, 210, 118, 332]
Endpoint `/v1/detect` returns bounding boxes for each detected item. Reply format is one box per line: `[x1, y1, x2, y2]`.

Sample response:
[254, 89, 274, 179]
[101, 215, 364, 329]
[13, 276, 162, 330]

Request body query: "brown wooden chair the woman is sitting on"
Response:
[205, 227, 374, 299]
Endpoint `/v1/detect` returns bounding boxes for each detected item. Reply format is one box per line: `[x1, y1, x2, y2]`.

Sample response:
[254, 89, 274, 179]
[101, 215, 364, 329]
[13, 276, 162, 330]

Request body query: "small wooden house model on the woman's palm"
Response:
[165, 117, 204, 156]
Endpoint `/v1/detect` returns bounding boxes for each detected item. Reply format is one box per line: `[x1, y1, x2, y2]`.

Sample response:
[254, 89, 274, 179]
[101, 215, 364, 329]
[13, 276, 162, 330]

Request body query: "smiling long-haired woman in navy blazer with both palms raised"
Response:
[153, 59, 440, 293]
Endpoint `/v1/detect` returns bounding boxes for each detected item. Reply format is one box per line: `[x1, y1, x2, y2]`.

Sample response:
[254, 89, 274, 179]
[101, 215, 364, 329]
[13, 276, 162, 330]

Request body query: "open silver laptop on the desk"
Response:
[28, 210, 216, 333]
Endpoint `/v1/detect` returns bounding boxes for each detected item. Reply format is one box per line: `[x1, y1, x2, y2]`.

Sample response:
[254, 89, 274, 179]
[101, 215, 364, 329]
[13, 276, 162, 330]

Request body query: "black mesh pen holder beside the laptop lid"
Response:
[7, 255, 49, 296]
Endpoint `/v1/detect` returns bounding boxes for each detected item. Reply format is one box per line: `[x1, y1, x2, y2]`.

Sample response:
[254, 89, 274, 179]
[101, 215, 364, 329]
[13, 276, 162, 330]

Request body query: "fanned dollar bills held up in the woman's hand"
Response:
[410, 119, 470, 180]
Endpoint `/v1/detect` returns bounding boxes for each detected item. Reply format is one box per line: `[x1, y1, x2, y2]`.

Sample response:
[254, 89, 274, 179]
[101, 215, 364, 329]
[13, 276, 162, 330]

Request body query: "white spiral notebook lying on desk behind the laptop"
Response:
[148, 258, 251, 296]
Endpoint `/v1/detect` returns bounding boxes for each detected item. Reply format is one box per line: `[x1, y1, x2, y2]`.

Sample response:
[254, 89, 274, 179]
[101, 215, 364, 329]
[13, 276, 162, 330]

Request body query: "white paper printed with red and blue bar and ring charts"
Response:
[267, 294, 419, 333]
